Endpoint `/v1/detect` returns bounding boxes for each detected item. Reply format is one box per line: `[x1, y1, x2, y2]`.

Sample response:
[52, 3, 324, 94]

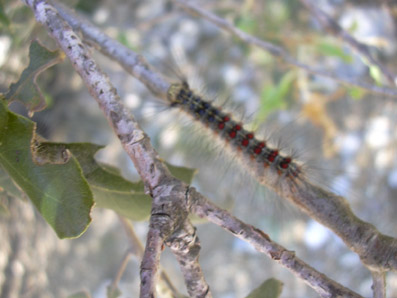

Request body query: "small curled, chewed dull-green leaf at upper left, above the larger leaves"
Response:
[5, 41, 64, 113]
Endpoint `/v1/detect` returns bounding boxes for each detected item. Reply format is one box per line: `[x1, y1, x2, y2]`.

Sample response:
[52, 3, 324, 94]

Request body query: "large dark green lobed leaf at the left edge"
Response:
[0, 100, 93, 238]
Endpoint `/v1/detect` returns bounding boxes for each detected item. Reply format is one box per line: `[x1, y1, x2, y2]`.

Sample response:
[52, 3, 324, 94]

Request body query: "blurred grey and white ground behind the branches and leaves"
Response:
[0, 0, 397, 298]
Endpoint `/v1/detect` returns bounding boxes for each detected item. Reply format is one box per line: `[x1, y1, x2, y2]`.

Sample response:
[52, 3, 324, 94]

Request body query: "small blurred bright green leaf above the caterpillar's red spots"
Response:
[255, 71, 296, 123]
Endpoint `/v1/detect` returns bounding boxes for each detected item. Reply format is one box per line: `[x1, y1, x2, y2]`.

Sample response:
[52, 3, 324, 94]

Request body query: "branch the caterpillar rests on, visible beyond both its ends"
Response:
[49, 1, 397, 271]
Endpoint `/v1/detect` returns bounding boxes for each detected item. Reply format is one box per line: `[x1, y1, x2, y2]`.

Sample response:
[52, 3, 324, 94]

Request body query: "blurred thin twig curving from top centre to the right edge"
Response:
[173, 0, 397, 97]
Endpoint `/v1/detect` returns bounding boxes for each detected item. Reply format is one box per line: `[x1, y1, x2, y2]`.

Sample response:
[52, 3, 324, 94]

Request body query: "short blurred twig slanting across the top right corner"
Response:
[300, 0, 396, 85]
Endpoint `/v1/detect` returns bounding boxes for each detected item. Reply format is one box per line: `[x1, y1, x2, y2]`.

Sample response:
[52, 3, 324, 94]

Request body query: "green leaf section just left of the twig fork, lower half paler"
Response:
[65, 143, 152, 221]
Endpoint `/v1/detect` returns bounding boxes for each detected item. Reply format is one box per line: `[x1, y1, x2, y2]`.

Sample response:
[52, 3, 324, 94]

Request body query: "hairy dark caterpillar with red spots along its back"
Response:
[167, 81, 303, 197]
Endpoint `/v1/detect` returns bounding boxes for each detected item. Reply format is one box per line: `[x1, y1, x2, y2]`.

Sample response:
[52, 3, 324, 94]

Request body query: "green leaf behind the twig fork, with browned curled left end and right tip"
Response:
[28, 142, 195, 221]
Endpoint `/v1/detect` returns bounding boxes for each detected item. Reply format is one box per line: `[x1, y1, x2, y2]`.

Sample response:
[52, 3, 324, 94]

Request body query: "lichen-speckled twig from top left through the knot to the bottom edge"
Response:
[25, 0, 211, 297]
